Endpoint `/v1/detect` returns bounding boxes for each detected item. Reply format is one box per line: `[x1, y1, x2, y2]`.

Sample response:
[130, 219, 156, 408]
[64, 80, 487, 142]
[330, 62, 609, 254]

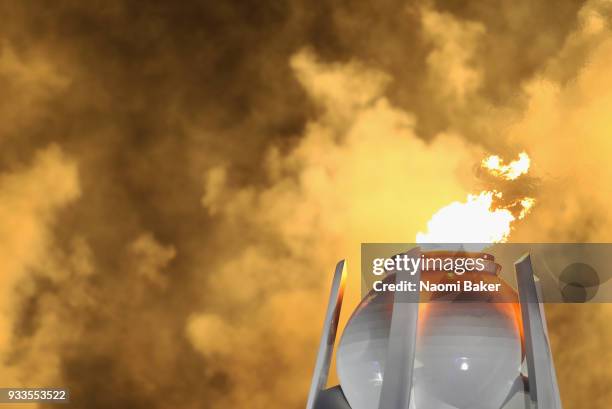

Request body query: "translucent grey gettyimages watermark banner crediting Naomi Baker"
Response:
[361, 243, 612, 303]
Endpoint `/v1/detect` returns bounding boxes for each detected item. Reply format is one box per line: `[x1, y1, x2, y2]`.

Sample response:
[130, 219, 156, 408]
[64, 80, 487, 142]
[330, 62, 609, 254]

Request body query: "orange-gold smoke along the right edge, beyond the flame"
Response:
[509, 2, 612, 242]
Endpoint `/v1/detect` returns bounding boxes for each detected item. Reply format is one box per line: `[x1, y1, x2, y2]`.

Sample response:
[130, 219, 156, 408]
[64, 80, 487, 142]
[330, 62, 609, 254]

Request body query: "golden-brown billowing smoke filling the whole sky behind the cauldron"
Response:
[0, 0, 612, 409]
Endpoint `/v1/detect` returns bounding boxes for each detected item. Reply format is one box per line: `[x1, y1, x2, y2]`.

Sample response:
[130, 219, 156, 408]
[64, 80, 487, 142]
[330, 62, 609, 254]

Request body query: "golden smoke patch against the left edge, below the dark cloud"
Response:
[0, 146, 80, 386]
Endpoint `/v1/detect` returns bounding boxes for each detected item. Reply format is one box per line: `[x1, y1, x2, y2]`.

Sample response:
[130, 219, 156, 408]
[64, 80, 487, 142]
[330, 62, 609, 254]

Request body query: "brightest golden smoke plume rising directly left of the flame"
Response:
[188, 51, 481, 408]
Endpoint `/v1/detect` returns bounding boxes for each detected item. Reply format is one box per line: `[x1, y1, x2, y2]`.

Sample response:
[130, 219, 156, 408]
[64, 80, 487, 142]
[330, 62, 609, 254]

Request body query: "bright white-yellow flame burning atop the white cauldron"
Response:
[416, 152, 535, 243]
